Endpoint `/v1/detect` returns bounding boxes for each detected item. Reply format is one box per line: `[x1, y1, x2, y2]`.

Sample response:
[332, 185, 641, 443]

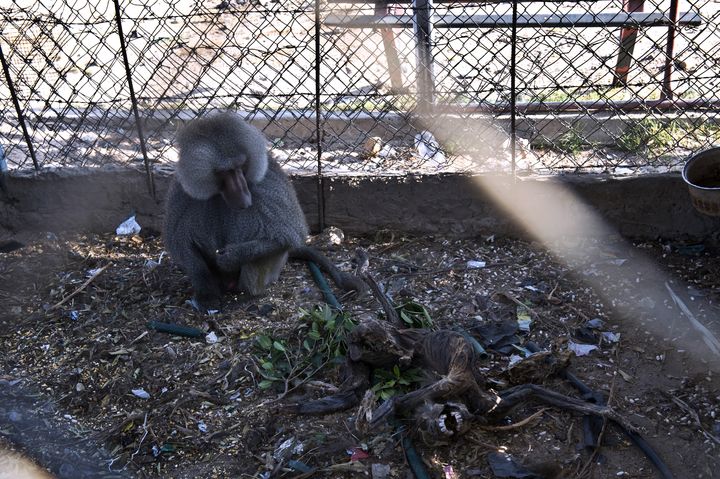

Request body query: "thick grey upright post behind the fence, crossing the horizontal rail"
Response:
[412, 0, 435, 113]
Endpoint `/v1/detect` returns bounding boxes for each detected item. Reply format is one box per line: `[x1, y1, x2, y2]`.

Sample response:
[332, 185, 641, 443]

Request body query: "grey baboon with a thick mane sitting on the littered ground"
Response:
[164, 112, 364, 307]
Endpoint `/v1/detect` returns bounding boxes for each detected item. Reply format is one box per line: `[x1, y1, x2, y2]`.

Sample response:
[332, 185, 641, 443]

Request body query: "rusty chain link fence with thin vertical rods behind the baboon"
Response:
[0, 0, 720, 182]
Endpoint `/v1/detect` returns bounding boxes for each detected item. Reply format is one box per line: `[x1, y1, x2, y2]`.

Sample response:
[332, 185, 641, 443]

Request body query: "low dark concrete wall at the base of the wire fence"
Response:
[0, 168, 720, 239]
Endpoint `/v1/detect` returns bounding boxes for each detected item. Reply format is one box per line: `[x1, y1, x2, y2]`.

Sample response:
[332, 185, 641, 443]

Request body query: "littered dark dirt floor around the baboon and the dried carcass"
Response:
[0, 230, 720, 479]
